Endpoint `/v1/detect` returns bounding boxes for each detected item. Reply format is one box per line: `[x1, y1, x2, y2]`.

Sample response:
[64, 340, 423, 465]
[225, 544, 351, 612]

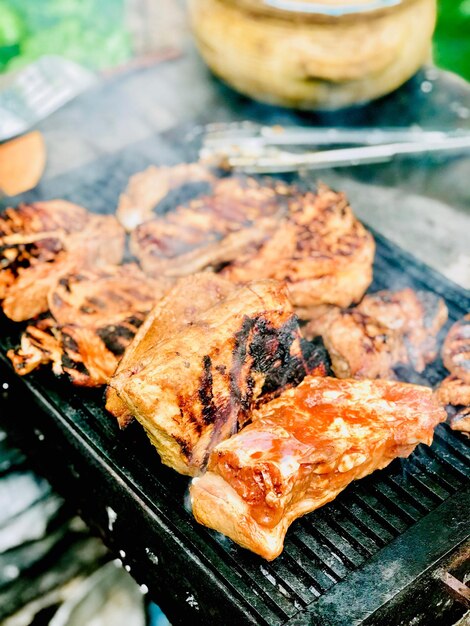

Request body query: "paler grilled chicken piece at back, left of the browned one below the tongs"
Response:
[131, 178, 292, 276]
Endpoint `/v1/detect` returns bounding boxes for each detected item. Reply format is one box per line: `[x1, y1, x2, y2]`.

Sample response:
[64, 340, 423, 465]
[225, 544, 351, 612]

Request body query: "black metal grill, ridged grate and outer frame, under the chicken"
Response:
[0, 146, 470, 626]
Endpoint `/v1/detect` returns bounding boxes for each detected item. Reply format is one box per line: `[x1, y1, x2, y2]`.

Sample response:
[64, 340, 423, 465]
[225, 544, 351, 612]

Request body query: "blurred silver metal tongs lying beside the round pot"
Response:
[199, 122, 470, 174]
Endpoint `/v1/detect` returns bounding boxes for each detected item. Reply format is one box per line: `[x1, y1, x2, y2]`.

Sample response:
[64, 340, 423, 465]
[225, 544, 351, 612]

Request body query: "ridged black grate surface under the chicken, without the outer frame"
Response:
[0, 138, 470, 626]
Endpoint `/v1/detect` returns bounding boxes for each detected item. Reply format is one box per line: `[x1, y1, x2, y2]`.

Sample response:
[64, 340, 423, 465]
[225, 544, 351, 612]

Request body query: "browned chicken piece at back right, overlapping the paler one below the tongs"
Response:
[223, 186, 375, 319]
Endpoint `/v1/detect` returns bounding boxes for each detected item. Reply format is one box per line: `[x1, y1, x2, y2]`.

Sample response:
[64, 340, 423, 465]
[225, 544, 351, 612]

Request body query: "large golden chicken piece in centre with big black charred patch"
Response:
[110, 281, 328, 475]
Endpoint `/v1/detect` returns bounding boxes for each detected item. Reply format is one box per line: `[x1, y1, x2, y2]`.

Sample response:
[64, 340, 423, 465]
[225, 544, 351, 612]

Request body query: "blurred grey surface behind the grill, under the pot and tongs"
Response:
[25, 7, 470, 288]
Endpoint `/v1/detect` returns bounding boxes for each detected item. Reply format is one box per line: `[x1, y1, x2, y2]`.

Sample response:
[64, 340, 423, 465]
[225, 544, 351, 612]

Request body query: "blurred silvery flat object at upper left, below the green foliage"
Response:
[0, 56, 98, 141]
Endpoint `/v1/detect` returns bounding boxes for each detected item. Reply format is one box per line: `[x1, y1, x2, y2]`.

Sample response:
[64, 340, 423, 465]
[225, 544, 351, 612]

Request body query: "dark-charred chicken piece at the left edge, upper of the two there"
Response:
[0, 200, 124, 321]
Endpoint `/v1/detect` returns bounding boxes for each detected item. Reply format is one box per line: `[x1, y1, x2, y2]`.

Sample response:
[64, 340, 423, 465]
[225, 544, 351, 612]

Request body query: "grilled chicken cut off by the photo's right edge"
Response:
[436, 313, 470, 432]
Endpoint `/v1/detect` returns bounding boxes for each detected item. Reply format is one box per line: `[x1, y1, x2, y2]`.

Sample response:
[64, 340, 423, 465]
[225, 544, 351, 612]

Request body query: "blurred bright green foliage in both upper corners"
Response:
[0, 0, 470, 80]
